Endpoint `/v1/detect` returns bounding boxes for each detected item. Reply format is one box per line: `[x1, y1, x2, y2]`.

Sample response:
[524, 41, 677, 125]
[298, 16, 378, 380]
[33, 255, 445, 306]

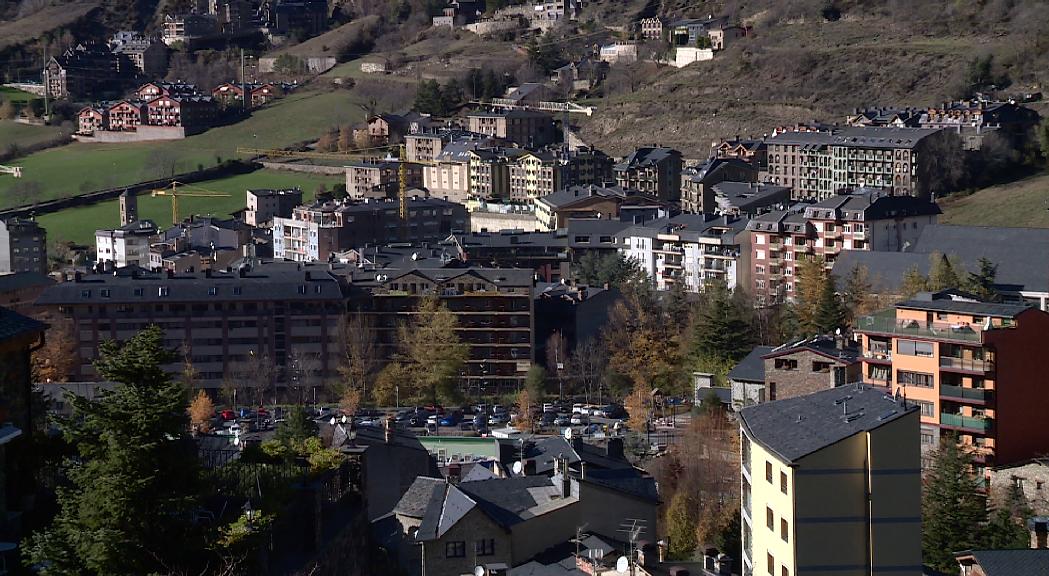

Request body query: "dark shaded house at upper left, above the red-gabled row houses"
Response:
[43, 43, 125, 99]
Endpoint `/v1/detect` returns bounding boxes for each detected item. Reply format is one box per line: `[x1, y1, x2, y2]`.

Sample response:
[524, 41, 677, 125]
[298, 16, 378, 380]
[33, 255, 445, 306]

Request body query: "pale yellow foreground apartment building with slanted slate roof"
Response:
[740, 386, 922, 576]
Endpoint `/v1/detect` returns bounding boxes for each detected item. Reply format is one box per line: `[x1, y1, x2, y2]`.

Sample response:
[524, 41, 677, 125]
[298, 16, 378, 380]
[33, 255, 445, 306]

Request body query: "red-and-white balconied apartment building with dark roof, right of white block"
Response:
[748, 189, 941, 302]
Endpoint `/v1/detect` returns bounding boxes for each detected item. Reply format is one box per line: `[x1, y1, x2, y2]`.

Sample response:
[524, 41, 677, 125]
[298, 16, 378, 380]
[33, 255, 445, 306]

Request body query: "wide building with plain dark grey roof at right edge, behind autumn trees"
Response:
[834, 225, 1049, 310]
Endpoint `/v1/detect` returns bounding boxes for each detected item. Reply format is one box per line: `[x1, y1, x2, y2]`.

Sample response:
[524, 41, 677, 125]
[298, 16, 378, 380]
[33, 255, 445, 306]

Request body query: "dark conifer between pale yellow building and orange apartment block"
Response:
[922, 435, 987, 573]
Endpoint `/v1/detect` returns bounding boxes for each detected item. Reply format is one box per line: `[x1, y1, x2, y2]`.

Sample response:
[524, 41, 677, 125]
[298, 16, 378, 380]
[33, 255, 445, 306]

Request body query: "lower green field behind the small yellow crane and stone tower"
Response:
[37, 170, 343, 246]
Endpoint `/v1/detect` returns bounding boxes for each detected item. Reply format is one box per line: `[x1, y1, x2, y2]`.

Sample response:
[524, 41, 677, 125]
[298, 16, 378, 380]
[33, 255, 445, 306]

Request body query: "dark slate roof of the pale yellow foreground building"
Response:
[740, 385, 918, 463]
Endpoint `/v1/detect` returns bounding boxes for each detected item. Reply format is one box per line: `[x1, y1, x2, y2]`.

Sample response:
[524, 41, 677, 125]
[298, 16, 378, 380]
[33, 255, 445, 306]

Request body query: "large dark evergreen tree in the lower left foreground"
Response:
[26, 326, 204, 576]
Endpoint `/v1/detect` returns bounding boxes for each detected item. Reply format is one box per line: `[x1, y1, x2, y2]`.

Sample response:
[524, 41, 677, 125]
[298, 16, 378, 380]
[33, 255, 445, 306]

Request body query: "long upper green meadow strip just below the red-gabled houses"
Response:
[0, 89, 361, 208]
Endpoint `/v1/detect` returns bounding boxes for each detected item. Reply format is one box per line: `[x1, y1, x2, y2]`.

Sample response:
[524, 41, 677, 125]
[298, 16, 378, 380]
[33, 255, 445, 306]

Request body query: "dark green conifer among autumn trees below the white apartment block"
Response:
[690, 279, 754, 361]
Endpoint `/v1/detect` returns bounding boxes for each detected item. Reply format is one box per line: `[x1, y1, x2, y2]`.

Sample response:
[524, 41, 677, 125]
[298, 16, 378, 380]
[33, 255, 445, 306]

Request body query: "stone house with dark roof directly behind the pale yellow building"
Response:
[762, 336, 862, 402]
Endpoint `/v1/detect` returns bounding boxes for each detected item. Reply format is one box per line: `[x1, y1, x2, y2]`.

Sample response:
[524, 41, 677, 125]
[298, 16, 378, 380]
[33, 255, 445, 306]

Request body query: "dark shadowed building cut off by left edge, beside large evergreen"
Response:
[0, 307, 47, 541]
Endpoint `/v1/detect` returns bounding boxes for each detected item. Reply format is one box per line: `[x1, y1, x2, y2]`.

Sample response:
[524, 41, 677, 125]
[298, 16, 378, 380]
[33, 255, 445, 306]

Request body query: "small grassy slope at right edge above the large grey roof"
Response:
[940, 172, 1049, 228]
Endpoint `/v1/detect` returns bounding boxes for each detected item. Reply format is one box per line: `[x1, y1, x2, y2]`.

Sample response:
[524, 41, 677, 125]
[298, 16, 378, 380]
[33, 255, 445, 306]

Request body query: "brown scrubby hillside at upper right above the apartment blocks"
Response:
[580, 0, 1049, 156]
